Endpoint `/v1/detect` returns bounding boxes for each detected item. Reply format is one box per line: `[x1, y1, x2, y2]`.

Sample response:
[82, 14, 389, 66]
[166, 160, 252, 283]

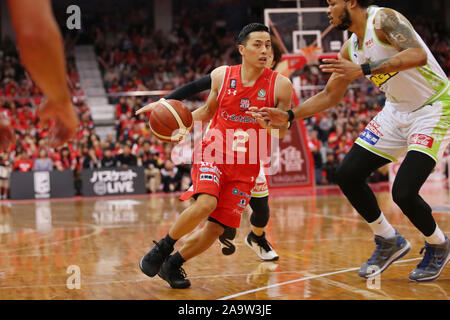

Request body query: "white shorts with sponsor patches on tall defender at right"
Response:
[355, 86, 450, 162]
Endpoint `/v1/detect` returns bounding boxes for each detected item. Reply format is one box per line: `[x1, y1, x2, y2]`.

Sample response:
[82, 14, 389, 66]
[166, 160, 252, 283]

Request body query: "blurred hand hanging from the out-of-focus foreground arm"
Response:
[39, 101, 78, 148]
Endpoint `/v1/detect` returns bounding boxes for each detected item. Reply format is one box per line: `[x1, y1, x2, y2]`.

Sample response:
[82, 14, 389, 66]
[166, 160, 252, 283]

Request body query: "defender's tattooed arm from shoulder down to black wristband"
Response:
[369, 8, 427, 74]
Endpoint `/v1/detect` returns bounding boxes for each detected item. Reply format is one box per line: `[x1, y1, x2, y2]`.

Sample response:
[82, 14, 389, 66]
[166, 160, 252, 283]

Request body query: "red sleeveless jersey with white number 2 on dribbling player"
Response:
[195, 65, 278, 174]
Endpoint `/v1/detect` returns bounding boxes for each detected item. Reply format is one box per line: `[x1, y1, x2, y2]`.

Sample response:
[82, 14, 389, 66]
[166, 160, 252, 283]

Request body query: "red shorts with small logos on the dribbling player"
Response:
[180, 162, 259, 228]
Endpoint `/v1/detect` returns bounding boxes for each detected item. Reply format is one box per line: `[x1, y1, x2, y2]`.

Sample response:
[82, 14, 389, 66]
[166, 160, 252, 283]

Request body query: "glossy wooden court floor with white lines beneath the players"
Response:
[0, 185, 450, 300]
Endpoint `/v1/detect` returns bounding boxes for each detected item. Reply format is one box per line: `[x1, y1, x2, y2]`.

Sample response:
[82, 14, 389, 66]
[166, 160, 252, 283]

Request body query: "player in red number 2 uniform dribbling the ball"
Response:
[139, 23, 292, 288]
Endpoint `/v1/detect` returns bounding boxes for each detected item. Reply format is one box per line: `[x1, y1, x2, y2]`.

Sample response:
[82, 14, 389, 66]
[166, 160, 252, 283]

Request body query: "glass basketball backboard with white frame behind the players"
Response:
[264, 7, 348, 54]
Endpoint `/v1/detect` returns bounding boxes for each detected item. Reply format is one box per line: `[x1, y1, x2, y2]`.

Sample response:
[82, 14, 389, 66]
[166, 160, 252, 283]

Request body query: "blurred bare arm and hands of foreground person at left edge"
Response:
[0, 0, 78, 151]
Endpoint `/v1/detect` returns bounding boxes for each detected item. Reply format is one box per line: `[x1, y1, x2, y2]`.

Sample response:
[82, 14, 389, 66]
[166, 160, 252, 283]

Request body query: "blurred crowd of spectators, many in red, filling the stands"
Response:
[0, 5, 450, 199]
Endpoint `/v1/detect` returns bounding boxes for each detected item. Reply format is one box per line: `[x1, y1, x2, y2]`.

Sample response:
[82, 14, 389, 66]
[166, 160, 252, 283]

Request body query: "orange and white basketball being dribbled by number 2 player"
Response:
[150, 100, 192, 143]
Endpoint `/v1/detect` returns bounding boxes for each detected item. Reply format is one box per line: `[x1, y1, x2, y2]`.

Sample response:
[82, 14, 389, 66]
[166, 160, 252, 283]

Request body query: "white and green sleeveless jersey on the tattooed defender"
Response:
[348, 6, 449, 112]
